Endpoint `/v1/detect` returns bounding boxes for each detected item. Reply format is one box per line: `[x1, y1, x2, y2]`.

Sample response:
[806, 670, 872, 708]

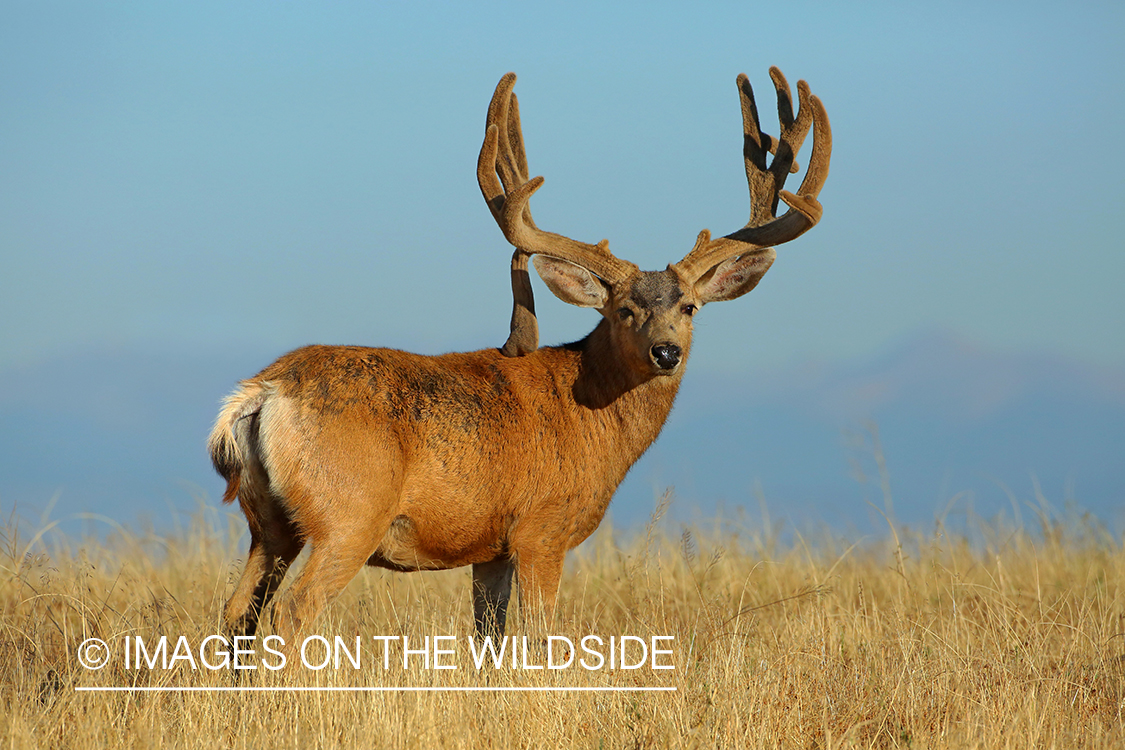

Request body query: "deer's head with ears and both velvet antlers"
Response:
[477, 67, 831, 379]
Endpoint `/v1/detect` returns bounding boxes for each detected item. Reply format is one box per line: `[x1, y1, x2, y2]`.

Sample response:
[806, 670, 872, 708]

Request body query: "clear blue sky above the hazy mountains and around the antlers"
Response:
[0, 2, 1125, 375]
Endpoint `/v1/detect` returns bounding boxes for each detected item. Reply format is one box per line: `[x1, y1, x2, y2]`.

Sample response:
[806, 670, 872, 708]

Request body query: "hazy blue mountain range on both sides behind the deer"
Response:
[0, 333, 1125, 533]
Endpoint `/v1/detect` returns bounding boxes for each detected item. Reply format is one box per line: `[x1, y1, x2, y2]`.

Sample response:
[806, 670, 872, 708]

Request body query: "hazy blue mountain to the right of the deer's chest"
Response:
[646, 333, 1125, 531]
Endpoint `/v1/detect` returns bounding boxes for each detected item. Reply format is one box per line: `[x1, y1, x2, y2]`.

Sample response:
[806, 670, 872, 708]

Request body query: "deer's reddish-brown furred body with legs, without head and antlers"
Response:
[209, 314, 680, 632]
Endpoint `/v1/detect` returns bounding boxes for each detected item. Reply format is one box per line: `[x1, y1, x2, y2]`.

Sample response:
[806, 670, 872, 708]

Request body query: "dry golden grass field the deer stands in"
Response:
[0, 494, 1125, 749]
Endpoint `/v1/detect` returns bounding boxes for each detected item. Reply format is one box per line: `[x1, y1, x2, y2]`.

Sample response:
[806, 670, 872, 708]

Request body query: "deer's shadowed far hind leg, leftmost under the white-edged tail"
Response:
[223, 493, 305, 635]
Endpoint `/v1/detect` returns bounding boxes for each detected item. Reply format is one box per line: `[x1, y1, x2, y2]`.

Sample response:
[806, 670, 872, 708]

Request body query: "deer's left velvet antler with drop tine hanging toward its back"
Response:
[477, 73, 637, 356]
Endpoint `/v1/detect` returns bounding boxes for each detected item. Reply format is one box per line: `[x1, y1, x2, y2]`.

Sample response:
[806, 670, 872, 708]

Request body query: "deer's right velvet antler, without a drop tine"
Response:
[676, 67, 833, 283]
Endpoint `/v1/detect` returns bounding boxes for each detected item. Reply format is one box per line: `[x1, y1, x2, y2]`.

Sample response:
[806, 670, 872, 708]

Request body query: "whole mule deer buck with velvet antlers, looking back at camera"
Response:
[209, 67, 831, 641]
